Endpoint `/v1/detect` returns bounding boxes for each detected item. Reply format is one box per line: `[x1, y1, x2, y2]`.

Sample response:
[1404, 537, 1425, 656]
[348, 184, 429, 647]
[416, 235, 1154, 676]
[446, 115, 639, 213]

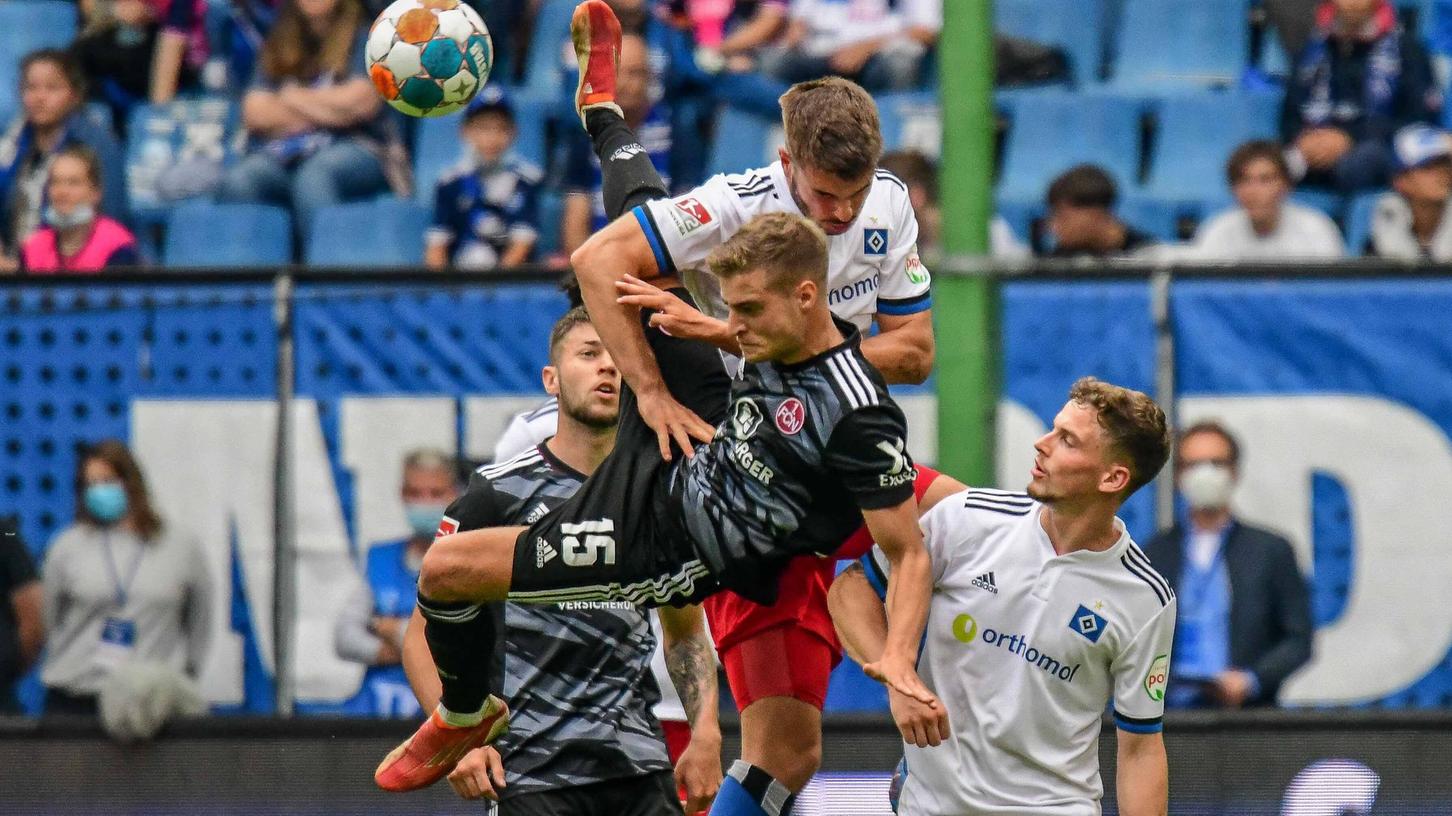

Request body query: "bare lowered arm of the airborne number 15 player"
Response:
[862, 497, 942, 707]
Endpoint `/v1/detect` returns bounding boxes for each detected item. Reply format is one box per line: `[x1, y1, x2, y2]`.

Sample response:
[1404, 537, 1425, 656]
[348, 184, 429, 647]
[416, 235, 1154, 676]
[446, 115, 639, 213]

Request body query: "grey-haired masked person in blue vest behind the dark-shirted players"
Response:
[333, 449, 459, 717]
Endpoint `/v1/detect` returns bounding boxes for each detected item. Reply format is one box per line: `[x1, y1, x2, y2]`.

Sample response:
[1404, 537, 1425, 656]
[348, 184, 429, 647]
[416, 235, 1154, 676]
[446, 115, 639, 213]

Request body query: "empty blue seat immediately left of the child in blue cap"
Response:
[303, 196, 428, 266]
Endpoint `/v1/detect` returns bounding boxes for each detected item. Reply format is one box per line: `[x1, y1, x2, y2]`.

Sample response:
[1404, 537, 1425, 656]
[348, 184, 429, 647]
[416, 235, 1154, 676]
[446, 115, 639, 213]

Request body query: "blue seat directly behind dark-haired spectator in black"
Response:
[999, 91, 1141, 200]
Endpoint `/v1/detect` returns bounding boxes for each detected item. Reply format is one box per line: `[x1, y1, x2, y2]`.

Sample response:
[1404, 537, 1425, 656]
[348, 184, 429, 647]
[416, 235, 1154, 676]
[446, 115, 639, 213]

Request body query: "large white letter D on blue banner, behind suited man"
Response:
[1180, 395, 1452, 704]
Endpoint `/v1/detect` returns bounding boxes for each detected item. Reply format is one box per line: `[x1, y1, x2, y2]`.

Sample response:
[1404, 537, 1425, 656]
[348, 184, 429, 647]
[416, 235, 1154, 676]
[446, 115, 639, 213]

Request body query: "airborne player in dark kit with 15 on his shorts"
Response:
[375, 213, 942, 800]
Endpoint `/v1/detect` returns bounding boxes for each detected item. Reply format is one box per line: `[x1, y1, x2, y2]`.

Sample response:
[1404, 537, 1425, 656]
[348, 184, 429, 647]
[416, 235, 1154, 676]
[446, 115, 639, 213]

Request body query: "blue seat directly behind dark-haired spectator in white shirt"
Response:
[1146, 91, 1281, 202]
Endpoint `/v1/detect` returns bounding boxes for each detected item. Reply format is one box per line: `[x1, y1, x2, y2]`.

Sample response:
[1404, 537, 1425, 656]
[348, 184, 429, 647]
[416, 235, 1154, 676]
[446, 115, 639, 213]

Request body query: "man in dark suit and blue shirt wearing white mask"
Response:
[1144, 423, 1313, 709]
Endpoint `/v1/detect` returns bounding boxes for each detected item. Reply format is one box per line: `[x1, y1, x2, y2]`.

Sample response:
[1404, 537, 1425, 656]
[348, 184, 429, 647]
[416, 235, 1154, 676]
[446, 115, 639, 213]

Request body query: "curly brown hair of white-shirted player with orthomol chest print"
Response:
[1069, 378, 1170, 498]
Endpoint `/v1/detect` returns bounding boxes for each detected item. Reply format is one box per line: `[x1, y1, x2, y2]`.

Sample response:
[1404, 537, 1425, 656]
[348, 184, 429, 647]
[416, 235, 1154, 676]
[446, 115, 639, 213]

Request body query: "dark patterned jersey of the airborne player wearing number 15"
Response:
[671, 319, 916, 604]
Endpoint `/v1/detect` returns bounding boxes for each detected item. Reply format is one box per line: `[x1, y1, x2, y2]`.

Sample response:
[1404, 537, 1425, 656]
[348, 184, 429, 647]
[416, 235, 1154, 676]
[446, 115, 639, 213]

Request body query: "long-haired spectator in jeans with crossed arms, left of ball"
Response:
[218, 0, 408, 235]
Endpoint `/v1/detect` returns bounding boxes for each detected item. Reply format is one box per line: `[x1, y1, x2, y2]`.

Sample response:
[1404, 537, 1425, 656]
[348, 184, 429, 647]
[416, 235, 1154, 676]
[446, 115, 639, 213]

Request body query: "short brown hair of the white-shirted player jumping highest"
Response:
[780, 77, 883, 180]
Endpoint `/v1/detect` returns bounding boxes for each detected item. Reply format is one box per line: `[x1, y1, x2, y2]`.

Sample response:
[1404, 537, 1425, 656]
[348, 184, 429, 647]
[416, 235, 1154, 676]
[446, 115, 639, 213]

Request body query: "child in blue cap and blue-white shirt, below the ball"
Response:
[424, 86, 540, 269]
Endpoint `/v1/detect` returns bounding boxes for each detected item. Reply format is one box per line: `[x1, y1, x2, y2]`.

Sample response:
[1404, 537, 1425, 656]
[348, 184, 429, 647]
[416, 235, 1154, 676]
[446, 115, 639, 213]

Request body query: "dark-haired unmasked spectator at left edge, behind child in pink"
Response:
[0, 48, 126, 270]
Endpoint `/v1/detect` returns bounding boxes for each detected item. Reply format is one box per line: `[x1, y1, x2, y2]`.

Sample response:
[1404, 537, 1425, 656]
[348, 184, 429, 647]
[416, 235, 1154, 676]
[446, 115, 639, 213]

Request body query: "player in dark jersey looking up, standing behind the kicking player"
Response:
[404, 308, 722, 816]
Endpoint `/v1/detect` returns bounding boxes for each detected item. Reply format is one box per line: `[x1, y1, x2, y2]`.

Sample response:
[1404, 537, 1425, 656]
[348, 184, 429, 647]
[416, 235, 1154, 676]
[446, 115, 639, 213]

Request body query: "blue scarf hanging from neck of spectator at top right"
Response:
[1298, 3, 1401, 126]
